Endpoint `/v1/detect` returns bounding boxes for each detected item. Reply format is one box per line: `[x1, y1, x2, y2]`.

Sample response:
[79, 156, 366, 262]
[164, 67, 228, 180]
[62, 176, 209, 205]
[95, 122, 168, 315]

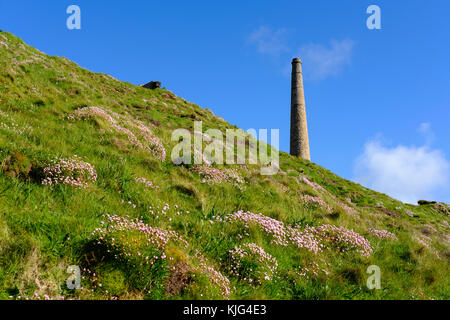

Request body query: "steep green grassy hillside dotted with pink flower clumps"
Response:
[0, 32, 450, 299]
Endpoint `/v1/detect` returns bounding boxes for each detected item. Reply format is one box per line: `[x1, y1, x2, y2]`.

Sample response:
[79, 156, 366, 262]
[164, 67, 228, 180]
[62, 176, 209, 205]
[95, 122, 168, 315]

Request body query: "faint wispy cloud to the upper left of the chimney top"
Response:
[247, 26, 289, 56]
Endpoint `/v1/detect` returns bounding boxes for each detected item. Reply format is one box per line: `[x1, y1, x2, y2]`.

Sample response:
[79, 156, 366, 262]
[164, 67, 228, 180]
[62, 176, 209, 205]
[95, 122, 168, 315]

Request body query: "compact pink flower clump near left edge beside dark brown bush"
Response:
[42, 155, 97, 188]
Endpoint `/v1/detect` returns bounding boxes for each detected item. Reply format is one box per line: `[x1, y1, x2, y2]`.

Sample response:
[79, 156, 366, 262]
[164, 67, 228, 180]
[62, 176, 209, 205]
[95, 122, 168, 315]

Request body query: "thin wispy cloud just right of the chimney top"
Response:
[298, 39, 355, 80]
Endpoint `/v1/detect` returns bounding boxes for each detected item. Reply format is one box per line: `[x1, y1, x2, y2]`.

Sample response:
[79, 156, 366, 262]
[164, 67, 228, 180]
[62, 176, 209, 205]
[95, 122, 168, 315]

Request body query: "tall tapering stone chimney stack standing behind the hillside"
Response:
[290, 58, 311, 160]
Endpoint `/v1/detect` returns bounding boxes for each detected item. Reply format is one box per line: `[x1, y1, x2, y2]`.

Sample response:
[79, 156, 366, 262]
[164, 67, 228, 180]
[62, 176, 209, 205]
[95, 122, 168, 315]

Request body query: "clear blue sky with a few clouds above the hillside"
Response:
[0, 0, 450, 202]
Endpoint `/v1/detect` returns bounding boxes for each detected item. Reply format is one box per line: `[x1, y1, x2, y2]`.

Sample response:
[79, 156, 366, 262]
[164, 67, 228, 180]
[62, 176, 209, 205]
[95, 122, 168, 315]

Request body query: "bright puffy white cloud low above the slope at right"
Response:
[355, 134, 450, 203]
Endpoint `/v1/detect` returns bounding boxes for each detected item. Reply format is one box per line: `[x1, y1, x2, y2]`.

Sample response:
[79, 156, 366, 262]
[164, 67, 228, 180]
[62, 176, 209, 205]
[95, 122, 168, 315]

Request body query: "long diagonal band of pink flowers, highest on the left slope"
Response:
[67, 107, 166, 161]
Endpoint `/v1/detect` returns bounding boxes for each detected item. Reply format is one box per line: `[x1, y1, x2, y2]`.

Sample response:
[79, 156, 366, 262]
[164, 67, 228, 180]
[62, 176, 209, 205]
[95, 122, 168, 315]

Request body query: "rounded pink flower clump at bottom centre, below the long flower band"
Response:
[230, 243, 278, 284]
